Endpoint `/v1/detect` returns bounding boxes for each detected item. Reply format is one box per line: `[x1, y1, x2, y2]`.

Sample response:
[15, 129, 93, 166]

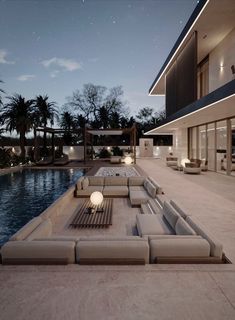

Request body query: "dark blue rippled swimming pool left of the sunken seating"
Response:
[0, 169, 85, 245]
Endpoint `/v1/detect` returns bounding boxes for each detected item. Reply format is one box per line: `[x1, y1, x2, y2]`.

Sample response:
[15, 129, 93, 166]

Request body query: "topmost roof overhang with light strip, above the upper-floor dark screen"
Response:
[149, 0, 235, 95]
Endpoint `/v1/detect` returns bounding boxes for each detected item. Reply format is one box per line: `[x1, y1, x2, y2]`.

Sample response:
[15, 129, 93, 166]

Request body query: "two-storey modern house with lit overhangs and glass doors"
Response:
[146, 0, 235, 175]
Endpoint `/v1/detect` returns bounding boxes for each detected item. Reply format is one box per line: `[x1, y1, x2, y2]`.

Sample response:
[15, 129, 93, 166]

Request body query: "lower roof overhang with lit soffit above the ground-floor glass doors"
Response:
[145, 80, 235, 135]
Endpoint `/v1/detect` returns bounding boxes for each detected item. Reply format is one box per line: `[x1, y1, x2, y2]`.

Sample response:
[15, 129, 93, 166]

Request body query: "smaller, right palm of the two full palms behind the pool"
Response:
[34, 95, 58, 150]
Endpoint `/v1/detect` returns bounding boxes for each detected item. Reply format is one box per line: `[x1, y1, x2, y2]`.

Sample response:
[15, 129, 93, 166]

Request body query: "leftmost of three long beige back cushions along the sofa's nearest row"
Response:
[1, 241, 75, 264]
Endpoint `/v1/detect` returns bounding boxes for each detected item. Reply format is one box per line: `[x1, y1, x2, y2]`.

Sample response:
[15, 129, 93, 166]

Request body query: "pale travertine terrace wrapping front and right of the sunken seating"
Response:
[0, 159, 235, 320]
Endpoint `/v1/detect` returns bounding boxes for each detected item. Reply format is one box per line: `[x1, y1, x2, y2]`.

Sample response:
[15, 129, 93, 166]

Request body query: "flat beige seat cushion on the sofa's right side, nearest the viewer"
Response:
[136, 213, 174, 236]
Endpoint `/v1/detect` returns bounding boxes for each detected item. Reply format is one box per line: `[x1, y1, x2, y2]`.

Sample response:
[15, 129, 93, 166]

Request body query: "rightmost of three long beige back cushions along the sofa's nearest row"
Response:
[150, 238, 210, 262]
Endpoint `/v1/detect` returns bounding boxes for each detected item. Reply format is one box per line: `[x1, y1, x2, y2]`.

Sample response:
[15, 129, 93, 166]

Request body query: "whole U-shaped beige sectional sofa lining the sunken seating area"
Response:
[1, 177, 224, 264]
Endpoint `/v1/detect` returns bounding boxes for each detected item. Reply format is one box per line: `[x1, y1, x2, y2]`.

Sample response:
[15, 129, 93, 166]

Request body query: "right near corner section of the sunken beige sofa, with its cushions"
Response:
[136, 200, 223, 263]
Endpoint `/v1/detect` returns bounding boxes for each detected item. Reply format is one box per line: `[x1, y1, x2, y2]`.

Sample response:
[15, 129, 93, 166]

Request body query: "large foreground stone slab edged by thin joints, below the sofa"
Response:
[0, 267, 235, 320]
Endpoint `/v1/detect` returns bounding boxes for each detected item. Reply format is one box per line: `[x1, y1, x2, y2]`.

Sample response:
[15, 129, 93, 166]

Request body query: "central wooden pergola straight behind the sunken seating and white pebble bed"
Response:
[84, 123, 136, 163]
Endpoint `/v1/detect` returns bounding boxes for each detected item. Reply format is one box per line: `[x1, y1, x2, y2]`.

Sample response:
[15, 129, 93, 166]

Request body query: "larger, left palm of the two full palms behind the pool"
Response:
[0, 94, 33, 158]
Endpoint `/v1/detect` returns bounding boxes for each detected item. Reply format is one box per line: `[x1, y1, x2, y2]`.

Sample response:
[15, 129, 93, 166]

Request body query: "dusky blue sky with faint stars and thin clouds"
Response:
[0, 0, 197, 115]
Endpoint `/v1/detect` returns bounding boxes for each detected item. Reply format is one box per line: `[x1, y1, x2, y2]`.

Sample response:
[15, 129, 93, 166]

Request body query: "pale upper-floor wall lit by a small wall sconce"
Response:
[209, 27, 235, 92]
